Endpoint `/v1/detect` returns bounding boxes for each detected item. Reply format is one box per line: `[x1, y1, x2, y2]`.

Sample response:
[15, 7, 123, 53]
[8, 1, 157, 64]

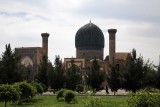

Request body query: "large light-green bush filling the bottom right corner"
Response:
[127, 90, 160, 107]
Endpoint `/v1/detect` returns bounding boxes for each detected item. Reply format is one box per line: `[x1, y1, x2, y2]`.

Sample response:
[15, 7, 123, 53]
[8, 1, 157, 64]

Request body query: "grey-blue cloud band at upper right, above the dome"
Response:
[72, 0, 160, 22]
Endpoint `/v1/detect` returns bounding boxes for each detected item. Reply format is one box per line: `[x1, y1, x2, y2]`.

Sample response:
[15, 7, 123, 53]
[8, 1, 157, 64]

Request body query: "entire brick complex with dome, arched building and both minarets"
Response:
[15, 22, 130, 85]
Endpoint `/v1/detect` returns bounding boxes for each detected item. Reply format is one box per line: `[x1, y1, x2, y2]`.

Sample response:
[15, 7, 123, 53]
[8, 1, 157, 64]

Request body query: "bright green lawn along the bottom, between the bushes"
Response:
[0, 96, 126, 107]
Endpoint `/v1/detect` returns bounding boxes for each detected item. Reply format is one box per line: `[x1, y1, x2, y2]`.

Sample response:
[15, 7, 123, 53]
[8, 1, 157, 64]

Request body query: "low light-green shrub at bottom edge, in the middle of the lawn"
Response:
[85, 97, 106, 107]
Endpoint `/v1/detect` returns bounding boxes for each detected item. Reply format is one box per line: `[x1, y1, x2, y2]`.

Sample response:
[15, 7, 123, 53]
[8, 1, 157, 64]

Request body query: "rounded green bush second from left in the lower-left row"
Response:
[14, 82, 36, 102]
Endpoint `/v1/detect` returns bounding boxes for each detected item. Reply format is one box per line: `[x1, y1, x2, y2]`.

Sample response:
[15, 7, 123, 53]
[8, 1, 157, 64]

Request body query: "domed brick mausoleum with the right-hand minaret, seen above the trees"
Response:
[64, 22, 130, 88]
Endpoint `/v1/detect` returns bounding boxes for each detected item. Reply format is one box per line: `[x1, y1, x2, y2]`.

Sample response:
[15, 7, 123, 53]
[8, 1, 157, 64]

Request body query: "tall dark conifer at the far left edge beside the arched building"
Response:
[0, 44, 22, 84]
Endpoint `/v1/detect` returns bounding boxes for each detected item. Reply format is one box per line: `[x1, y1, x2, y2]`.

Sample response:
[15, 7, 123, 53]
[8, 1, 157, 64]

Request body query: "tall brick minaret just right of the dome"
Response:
[108, 29, 117, 64]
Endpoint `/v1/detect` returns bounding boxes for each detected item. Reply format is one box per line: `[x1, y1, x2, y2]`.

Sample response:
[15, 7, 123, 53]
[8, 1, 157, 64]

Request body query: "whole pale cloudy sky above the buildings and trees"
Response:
[0, 0, 160, 65]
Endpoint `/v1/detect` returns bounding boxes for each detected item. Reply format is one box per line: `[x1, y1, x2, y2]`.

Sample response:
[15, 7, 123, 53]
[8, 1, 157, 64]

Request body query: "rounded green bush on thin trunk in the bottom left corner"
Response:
[0, 84, 20, 107]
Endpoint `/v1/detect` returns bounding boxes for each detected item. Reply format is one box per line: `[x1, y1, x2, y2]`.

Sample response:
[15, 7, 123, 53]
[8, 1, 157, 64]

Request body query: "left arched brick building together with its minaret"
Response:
[15, 33, 49, 80]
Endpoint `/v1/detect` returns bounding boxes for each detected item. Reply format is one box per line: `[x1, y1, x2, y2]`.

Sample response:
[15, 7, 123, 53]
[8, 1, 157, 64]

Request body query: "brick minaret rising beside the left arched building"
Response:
[41, 33, 49, 57]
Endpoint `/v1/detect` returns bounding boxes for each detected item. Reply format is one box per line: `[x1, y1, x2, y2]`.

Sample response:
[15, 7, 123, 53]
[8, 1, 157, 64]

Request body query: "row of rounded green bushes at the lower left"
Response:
[0, 82, 44, 107]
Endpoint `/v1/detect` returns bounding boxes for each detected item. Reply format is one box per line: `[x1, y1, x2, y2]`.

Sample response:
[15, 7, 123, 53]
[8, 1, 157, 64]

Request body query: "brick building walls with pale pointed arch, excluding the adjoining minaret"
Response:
[15, 47, 45, 80]
